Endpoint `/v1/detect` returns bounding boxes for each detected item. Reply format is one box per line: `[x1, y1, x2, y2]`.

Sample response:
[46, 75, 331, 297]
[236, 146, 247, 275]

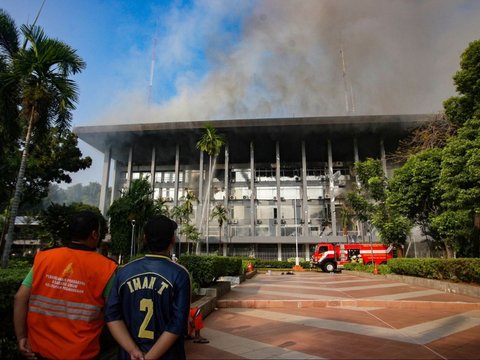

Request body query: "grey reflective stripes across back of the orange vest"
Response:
[29, 295, 102, 321]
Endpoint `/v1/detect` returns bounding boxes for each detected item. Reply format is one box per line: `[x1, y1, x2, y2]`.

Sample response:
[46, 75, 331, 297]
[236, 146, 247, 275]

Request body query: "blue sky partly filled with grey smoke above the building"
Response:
[0, 0, 480, 186]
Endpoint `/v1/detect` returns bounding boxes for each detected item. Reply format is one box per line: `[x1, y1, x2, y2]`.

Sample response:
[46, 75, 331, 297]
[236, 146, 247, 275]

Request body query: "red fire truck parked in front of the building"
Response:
[312, 243, 393, 272]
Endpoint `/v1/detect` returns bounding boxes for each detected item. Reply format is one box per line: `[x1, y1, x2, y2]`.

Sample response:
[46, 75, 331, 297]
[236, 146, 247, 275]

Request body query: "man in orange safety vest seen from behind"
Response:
[13, 211, 117, 359]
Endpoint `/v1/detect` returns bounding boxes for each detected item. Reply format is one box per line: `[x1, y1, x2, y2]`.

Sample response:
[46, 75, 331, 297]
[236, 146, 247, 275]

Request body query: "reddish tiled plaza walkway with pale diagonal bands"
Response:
[186, 272, 480, 359]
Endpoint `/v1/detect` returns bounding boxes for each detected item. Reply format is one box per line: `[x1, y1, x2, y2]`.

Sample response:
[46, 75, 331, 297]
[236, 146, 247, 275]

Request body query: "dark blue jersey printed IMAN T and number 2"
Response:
[105, 254, 191, 359]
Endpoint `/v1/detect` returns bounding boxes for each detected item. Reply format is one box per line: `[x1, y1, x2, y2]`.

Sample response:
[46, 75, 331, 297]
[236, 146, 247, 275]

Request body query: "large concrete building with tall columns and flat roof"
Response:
[74, 115, 430, 259]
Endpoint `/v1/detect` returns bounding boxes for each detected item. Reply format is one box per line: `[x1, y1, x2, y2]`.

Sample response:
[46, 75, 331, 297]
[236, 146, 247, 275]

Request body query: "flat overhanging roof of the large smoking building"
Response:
[73, 114, 432, 156]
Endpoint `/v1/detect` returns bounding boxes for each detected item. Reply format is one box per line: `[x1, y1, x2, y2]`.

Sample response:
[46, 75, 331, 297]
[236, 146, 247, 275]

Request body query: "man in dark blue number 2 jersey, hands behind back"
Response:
[105, 215, 191, 359]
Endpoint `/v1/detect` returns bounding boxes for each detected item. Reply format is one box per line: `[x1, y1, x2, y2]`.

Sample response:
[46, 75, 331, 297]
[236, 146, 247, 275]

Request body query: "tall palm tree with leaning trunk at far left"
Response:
[0, 19, 86, 268]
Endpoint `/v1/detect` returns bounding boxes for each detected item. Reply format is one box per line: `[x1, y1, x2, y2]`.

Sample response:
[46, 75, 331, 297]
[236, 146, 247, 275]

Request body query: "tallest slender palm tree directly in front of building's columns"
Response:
[197, 124, 225, 253]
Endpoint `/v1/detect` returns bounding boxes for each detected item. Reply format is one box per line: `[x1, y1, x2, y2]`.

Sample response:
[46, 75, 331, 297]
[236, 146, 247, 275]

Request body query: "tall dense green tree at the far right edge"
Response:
[432, 40, 480, 256]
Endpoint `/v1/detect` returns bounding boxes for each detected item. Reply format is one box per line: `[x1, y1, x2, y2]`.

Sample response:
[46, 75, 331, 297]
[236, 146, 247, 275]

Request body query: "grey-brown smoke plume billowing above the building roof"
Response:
[95, 0, 480, 124]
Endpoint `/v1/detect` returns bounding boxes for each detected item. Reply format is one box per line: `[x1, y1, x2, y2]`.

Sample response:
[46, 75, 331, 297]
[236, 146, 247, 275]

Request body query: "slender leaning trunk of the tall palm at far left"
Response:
[1, 108, 35, 269]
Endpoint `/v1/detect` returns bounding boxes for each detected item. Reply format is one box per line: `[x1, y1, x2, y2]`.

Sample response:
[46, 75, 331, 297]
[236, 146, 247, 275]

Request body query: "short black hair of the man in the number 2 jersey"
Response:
[143, 215, 177, 252]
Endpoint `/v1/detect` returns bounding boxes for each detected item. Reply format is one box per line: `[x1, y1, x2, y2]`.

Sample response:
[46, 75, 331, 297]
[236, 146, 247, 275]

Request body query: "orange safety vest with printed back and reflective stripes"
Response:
[27, 247, 117, 359]
